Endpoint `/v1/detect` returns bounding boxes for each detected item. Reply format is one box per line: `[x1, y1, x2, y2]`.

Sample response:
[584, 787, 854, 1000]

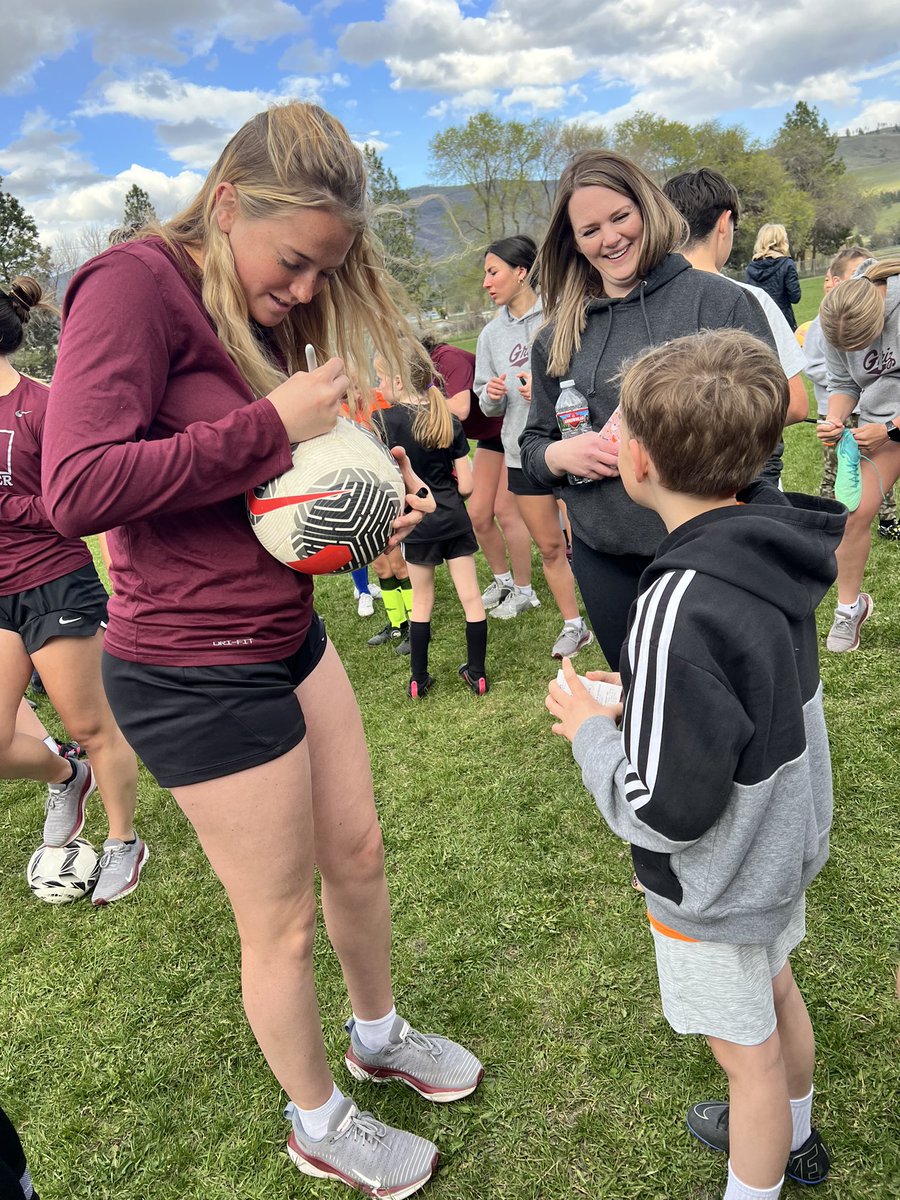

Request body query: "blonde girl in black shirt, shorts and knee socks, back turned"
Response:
[374, 356, 488, 700]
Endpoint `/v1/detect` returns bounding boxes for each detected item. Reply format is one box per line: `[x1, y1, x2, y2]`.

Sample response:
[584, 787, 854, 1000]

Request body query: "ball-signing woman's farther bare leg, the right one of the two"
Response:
[298, 648, 393, 1021]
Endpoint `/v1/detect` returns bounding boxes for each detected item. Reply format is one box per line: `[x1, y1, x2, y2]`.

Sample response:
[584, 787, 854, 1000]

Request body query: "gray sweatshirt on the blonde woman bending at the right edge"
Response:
[823, 275, 900, 425]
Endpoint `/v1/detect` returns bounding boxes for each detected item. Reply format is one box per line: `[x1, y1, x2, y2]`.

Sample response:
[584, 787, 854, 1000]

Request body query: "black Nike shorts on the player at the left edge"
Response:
[0, 563, 109, 654]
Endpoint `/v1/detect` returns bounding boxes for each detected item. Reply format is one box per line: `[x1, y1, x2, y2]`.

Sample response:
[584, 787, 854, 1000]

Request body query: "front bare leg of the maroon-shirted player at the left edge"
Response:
[32, 630, 138, 841]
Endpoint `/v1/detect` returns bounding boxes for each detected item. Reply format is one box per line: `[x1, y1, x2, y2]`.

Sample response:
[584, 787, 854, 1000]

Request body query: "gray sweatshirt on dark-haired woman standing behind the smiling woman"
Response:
[473, 296, 544, 467]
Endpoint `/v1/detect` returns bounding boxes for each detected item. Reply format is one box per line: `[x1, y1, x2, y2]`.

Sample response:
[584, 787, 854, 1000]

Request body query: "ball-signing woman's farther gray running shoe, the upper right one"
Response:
[344, 1016, 485, 1104]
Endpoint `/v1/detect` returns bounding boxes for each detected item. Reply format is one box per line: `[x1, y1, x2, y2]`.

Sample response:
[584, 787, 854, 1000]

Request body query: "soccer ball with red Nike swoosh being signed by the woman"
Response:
[247, 418, 406, 575]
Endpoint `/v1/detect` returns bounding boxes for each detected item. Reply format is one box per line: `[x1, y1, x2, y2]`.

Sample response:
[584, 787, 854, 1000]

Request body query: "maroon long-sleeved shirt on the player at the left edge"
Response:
[0, 376, 91, 596]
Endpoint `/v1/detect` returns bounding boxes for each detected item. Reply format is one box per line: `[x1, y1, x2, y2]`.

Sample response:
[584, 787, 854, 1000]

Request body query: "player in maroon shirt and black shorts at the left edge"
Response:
[0, 276, 148, 905]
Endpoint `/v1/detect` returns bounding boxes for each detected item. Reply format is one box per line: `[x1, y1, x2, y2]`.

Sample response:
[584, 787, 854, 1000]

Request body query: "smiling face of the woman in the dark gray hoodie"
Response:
[569, 186, 643, 296]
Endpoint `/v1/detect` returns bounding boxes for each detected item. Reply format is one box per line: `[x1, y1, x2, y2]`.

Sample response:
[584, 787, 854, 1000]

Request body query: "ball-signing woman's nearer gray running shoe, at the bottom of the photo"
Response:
[284, 1097, 438, 1200]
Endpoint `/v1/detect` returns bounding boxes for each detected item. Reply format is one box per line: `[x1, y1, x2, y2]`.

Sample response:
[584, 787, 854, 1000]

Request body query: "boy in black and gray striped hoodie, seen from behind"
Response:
[547, 330, 846, 1200]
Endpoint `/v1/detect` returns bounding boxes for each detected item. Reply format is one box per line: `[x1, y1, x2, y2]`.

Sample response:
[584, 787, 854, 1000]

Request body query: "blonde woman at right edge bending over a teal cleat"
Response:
[817, 258, 900, 654]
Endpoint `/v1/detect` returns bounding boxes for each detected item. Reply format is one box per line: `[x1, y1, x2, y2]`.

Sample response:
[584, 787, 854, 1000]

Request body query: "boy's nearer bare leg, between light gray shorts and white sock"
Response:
[707, 1031, 793, 1189]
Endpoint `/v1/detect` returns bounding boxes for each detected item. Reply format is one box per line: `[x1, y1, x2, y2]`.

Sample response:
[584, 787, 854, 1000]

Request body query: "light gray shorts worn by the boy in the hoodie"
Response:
[650, 896, 806, 1046]
